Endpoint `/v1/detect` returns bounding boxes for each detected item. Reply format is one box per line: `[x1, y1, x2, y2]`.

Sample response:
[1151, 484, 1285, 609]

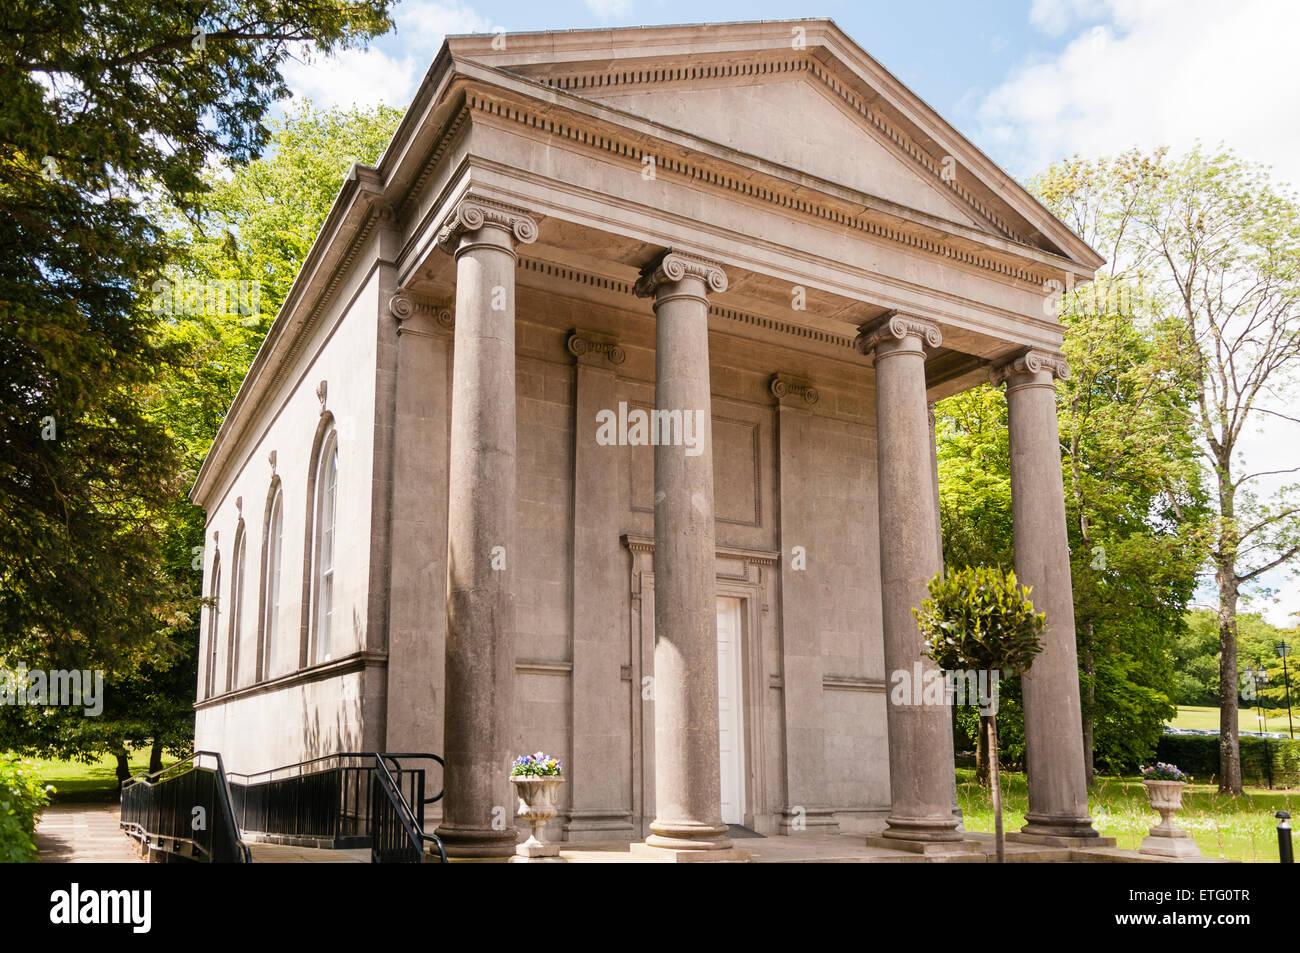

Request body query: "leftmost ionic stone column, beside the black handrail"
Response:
[438, 198, 537, 858]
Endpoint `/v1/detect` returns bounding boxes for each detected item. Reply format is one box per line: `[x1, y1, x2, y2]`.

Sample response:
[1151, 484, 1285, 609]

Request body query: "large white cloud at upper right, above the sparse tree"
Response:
[975, 0, 1300, 186]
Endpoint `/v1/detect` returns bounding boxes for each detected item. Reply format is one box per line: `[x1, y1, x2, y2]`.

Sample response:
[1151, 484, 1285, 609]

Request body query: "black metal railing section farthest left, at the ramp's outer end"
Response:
[121, 751, 252, 863]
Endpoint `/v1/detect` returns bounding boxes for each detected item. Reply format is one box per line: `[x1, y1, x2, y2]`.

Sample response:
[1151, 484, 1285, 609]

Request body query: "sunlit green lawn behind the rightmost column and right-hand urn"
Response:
[957, 768, 1300, 863]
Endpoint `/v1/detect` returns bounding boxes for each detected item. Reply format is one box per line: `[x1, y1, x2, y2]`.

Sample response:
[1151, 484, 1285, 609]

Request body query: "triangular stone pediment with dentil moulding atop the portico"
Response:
[449, 20, 1101, 268]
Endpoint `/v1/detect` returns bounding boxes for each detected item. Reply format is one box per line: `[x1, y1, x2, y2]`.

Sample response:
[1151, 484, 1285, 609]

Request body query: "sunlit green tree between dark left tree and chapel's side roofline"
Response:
[131, 104, 400, 767]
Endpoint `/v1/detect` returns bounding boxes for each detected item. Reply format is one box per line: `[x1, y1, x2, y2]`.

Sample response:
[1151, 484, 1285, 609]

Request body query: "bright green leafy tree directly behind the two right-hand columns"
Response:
[937, 157, 1208, 781]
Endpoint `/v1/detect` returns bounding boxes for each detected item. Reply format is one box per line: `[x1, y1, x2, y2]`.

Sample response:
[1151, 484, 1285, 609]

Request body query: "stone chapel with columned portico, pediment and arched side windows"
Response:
[192, 20, 1101, 857]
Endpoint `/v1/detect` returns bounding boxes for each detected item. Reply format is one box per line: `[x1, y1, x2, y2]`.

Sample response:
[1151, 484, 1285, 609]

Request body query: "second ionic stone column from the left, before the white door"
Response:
[636, 251, 731, 852]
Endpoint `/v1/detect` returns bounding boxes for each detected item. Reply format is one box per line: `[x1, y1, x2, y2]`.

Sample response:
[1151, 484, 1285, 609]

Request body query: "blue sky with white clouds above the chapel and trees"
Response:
[285, 0, 1300, 624]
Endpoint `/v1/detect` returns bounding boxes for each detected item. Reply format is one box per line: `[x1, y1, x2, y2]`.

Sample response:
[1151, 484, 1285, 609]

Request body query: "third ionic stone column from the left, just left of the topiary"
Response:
[857, 312, 962, 842]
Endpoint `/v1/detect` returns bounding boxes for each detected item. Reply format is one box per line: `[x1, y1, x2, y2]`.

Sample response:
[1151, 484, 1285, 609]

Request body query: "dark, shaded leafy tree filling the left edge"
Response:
[0, 0, 390, 759]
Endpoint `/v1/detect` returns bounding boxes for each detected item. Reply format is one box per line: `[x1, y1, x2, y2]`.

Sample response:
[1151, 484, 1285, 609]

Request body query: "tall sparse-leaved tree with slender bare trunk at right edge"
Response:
[1040, 147, 1300, 794]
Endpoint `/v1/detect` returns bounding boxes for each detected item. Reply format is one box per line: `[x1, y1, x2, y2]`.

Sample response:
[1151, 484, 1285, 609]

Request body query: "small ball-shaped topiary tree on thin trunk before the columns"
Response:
[911, 566, 1047, 863]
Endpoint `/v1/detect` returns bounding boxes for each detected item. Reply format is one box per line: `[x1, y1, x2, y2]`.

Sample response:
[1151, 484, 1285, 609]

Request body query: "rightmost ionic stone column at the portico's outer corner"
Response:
[993, 350, 1097, 837]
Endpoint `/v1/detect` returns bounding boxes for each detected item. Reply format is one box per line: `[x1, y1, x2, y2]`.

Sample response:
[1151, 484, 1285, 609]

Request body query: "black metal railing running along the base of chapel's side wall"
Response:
[229, 751, 442, 848]
